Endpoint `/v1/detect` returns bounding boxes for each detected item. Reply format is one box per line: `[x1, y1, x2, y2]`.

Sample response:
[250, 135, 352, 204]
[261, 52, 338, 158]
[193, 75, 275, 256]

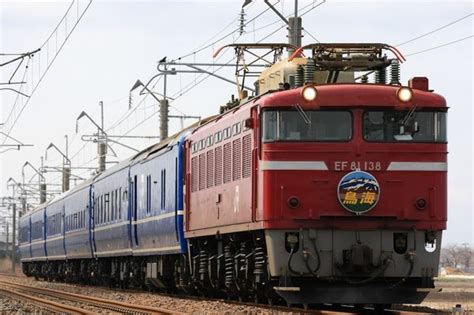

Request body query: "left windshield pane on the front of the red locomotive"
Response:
[263, 109, 352, 142]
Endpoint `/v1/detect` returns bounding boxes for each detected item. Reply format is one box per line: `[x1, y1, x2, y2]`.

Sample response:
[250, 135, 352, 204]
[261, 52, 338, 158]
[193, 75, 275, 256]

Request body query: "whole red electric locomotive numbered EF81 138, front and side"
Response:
[185, 44, 447, 304]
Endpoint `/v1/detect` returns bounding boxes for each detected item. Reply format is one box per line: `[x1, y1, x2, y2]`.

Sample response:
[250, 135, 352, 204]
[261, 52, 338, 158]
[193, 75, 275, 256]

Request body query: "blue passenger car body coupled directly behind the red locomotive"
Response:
[130, 138, 186, 256]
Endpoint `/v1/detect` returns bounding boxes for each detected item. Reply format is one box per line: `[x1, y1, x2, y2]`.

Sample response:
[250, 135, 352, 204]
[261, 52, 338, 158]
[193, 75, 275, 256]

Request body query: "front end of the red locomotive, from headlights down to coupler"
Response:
[257, 44, 447, 304]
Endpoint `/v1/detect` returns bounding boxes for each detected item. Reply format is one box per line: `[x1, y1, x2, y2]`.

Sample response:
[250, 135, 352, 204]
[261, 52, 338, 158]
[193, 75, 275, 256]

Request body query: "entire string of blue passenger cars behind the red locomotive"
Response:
[21, 127, 194, 288]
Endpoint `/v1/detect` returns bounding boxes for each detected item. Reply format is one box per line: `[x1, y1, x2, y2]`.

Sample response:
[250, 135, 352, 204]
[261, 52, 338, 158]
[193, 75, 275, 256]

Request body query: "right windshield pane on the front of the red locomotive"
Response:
[364, 110, 447, 142]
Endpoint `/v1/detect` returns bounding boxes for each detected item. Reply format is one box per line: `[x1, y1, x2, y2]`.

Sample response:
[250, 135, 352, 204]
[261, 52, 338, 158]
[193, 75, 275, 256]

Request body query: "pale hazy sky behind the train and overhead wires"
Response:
[0, 0, 474, 244]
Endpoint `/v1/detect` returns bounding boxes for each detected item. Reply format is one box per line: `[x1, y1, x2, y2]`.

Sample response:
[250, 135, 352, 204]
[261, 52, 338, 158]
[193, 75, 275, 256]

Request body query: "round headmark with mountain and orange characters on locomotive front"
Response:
[337, 171, 380, 215]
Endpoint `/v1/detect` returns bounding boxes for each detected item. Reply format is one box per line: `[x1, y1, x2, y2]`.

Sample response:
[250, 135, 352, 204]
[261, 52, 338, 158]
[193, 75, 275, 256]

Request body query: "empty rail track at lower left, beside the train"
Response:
[0, 280, 182, 314]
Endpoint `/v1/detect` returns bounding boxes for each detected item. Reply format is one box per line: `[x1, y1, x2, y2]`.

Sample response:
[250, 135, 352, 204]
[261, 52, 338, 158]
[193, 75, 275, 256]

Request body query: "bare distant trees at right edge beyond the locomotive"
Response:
[441, 244, 474, 269]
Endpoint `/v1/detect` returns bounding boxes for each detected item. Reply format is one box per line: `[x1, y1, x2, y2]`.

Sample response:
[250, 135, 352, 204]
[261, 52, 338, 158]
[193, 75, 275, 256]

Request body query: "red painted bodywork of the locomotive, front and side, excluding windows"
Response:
[186, 84, 447, 235]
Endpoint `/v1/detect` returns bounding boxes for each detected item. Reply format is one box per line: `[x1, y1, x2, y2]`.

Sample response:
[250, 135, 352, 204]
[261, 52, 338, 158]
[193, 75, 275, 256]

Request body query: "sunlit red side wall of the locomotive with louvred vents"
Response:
[185, 107, 255, 237]
